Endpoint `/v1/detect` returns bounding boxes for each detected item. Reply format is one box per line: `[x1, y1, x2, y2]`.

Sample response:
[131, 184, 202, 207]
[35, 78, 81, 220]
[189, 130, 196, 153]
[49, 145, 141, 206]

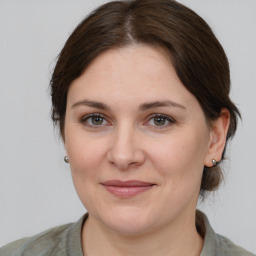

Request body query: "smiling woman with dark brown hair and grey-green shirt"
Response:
[0, 0, 253, 255]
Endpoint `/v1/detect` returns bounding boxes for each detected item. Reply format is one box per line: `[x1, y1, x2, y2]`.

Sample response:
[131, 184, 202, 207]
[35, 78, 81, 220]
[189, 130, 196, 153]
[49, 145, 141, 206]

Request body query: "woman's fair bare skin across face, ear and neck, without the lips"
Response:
[64, 45, 229, 256]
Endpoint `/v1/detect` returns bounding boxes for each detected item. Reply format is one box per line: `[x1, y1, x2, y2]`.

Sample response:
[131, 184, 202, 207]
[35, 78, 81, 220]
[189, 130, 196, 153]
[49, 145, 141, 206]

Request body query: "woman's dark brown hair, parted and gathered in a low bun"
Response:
[50, 0, 240, 195]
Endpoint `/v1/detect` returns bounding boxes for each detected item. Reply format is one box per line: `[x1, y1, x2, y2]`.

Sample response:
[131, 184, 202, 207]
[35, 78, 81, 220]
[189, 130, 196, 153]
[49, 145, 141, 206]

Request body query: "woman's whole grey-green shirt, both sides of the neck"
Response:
[0, 211, 256, 256]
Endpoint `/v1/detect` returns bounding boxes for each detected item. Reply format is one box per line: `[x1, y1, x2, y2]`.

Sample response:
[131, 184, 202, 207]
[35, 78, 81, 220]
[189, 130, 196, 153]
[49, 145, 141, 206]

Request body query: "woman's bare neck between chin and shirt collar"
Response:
[82, 210, 203, 256]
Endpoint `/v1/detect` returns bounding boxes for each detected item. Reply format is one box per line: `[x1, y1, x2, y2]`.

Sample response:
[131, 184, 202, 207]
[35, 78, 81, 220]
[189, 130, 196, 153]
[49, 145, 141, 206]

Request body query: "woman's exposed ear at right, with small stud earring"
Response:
[204, 108, 230, 167]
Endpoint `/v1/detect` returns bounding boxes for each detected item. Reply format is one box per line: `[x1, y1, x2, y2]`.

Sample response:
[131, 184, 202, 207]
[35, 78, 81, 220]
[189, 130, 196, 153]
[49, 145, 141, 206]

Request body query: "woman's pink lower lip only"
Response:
[102, 185, 153, 197]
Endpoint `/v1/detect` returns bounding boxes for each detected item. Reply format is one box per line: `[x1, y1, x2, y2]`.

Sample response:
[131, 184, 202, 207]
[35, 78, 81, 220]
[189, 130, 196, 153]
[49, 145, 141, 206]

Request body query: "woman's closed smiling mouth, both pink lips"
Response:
[101, 180, 156, 198]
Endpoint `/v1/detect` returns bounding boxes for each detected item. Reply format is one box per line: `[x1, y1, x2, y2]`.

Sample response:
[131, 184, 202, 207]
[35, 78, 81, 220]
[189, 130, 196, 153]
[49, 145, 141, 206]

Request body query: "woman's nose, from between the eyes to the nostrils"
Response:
[107, 126, 145, 170]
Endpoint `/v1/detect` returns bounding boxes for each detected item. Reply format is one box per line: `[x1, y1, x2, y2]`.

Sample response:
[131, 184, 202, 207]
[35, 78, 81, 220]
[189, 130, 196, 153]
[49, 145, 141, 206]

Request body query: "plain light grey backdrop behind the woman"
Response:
[0, 0, 256, 252]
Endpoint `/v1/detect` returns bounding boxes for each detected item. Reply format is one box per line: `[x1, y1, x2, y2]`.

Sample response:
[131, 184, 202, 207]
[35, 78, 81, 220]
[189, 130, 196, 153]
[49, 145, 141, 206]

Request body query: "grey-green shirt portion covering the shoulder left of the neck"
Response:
[0, 217, 84, 256]
